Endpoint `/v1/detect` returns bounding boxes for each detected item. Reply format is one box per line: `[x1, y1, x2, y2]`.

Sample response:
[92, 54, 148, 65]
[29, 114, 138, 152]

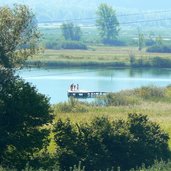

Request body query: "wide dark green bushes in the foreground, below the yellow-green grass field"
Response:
[54, 114, 169, 170]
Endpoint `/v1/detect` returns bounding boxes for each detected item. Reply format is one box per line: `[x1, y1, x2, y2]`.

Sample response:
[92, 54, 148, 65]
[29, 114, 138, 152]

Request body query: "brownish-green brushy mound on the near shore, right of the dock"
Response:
[96, 86, 168, 106]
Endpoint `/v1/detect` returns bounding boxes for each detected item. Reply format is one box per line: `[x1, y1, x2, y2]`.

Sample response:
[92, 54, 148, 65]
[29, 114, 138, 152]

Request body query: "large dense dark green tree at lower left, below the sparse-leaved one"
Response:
[0, 69, 52, 170]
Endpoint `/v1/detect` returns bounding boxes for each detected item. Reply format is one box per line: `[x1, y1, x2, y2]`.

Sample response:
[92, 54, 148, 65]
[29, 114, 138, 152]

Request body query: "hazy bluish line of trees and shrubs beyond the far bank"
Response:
[41, 3, 171, 53]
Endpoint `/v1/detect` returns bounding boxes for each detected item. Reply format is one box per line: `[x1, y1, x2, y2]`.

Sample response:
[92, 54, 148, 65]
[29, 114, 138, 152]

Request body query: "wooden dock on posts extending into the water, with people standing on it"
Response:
[67, 90, 108, 98]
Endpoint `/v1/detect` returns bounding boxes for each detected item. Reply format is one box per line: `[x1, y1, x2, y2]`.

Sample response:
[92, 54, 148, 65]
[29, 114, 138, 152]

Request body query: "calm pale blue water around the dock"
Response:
[19, 68, 171, 103]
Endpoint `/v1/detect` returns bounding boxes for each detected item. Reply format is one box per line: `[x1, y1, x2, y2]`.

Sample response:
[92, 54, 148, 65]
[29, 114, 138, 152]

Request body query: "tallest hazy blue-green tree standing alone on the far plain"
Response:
[96, 4, 119, 43]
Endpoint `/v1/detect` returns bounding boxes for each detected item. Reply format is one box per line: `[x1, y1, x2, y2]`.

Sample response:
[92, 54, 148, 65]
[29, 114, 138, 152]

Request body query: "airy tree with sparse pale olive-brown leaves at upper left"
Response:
[0, 5, 40, 68]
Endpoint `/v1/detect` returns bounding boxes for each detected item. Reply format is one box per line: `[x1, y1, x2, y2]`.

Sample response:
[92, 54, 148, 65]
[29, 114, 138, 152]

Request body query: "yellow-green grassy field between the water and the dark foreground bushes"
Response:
[49, 87, 171, 152]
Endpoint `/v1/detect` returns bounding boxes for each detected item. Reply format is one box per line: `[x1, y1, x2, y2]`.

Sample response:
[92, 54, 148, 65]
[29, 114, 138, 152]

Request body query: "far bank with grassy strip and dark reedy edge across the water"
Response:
[27, 46, 171, 68]
